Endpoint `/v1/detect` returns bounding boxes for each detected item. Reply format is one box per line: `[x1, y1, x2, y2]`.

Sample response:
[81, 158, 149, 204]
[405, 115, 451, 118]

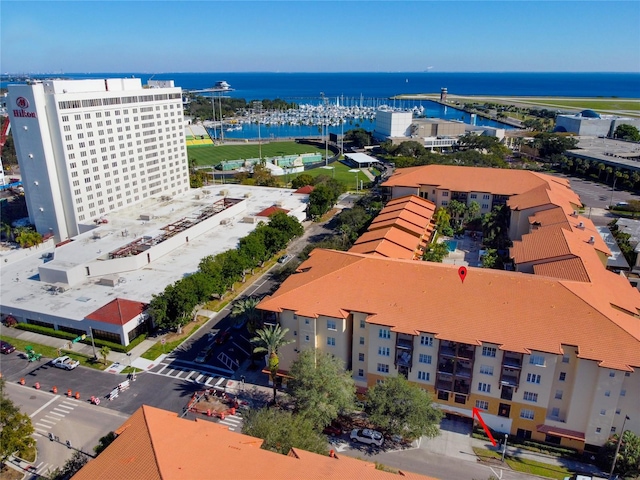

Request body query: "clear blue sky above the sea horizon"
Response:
[0, 0, 640, 73]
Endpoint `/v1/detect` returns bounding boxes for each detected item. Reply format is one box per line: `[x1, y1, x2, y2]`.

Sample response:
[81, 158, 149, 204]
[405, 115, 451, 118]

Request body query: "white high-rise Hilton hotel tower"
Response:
[7, 78, 189, 242]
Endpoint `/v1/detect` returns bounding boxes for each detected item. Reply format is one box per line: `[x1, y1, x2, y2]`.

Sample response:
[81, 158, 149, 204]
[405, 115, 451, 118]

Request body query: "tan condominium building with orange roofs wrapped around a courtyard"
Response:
[259, 166, 640, 450]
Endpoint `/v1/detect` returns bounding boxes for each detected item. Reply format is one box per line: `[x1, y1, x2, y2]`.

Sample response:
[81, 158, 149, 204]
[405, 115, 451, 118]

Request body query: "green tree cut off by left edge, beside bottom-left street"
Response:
[0, 378, 36, 464]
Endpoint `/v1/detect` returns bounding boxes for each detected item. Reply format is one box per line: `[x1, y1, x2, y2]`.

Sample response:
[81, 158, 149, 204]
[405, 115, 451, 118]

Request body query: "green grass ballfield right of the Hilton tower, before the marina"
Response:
[187, 142, 325, 165]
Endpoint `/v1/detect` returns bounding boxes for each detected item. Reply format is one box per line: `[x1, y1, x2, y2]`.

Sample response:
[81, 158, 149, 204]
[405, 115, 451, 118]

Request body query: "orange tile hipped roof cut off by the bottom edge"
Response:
[73, 406, 433, 480]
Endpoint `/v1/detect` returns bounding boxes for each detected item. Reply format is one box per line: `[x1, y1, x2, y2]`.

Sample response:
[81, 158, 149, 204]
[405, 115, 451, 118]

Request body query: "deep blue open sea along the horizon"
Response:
[0, 72, 640, 99]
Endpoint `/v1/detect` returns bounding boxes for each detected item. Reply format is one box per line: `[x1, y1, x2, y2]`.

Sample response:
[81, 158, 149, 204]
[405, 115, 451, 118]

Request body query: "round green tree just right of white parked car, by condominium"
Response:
[366, 375, 442, 439]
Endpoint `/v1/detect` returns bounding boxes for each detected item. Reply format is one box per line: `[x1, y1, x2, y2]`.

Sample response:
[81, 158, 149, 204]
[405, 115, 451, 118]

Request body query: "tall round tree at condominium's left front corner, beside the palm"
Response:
[287, 349, 356, 429]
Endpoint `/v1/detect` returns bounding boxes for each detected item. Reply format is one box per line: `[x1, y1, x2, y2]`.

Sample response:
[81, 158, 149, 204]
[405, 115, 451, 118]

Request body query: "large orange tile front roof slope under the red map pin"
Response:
[259, 249, 640, 370]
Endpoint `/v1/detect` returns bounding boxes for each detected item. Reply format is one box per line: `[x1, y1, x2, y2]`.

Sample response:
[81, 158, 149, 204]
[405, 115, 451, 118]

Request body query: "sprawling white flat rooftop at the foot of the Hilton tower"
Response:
[0, 185, 307, 320]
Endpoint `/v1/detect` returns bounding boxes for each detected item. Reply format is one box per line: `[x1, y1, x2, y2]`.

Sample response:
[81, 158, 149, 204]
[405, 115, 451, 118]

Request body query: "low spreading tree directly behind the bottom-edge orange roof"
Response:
[242, 408, 328, 455]
